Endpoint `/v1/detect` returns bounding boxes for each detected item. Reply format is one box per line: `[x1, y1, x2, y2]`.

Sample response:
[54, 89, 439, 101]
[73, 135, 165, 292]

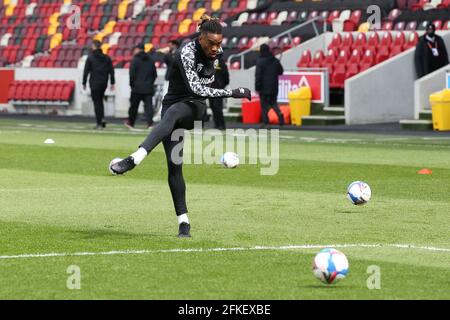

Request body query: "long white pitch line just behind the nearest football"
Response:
[0, 244, 450, 260]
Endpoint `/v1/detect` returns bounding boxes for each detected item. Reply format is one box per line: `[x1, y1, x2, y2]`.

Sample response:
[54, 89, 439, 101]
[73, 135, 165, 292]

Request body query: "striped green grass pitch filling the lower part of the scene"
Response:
[0, 119, 450, 299]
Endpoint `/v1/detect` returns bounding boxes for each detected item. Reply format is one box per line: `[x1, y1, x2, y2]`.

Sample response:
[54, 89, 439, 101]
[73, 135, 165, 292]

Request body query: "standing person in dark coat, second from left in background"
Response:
[124, 44, 158, 129]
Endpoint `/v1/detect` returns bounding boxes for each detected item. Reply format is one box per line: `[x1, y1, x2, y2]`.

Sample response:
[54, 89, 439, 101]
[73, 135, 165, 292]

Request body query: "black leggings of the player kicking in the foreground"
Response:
[140, 102, 198, 216]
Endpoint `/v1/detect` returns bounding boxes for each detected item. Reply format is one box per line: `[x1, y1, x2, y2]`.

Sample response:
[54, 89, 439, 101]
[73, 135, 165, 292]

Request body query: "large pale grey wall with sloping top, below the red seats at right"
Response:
[345, 32, 450, 124]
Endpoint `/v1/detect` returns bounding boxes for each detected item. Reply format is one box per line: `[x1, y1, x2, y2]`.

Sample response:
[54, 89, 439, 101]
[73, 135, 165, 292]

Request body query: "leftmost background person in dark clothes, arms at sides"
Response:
[83, 40, 116, 130]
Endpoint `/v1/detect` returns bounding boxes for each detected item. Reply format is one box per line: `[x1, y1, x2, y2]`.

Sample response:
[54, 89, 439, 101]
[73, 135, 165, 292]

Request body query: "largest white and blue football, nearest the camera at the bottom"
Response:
[313, 249, 348, 284]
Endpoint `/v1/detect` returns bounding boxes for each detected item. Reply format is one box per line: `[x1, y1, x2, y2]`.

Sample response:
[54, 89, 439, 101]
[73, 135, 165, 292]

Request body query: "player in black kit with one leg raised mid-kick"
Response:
[110, 15, 251, 238]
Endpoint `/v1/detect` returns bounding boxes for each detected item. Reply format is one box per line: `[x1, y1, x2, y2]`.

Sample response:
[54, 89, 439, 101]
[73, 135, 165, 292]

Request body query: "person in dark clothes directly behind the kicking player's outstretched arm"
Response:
[209, 57, 230, 130]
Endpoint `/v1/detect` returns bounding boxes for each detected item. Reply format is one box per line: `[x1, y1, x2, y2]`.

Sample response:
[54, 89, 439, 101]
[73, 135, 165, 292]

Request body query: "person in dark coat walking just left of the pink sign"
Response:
[255, 44, 284, 125]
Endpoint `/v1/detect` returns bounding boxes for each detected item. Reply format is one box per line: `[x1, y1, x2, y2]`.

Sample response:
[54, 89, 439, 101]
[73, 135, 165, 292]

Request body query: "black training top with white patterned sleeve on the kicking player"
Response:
[163, 39, 232, 107]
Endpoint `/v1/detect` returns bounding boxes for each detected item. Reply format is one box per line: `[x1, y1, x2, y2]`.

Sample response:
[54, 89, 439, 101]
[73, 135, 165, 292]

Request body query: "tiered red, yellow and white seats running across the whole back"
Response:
[0, 0, 442, 68]
